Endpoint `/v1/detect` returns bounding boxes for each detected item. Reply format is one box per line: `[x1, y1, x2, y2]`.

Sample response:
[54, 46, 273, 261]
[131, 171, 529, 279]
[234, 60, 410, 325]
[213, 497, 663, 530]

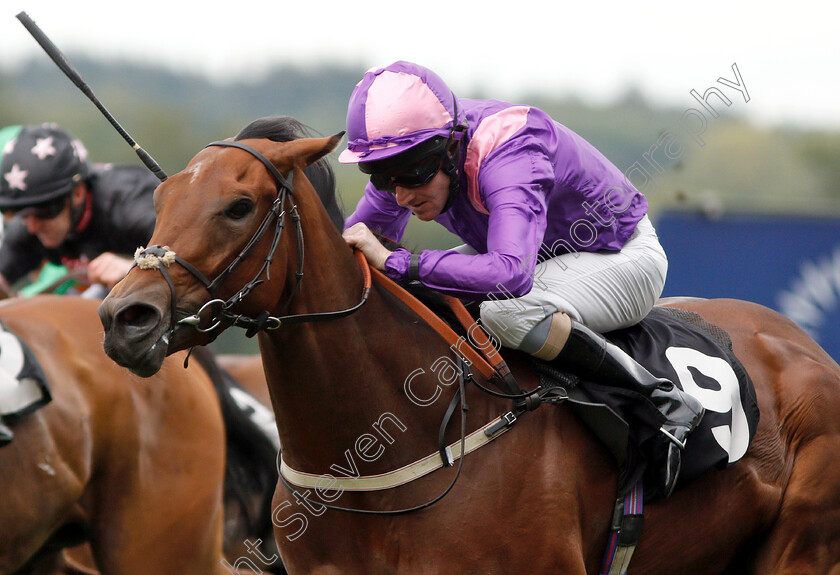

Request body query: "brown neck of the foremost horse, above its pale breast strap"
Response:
[259, 197, 451, 472]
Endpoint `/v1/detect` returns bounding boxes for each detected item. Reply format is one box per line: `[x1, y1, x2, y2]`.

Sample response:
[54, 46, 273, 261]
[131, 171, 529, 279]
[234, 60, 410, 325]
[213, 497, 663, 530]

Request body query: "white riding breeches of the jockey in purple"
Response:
[480, 216, 668, 352]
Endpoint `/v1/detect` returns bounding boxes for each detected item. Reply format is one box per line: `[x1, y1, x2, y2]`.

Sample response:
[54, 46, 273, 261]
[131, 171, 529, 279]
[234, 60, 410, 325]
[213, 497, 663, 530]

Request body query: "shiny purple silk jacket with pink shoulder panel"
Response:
[345, 99, 648, 300]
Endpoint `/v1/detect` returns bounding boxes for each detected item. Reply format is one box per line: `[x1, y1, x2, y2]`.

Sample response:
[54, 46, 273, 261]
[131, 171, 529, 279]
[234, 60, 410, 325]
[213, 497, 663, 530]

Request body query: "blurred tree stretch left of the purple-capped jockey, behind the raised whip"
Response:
[0, 55, 364, 173]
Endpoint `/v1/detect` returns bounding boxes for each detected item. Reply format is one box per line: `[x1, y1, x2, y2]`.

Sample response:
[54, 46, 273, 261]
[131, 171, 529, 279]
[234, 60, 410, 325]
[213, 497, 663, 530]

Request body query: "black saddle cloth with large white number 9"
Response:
[537, 308, 759, 500]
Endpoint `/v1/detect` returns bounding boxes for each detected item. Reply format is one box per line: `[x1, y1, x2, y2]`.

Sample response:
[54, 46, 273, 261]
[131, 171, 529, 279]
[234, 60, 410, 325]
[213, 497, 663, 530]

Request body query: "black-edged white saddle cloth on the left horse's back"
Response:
[0, 322, 52, 417]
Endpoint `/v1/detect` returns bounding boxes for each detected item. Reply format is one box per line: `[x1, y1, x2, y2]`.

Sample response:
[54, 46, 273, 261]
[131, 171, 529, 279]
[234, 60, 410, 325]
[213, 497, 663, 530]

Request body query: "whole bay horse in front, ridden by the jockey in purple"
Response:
[99, 118, 840, 575]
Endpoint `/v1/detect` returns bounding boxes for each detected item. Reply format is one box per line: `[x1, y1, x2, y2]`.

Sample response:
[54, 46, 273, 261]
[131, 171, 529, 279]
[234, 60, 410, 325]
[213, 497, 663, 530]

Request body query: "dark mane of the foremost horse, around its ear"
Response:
[234, 116, 344, 230]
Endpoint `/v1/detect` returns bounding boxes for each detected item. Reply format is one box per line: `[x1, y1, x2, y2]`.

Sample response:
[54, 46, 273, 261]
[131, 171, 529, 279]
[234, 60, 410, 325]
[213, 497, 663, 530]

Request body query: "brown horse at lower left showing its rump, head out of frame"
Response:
[0, 295, 276, 575]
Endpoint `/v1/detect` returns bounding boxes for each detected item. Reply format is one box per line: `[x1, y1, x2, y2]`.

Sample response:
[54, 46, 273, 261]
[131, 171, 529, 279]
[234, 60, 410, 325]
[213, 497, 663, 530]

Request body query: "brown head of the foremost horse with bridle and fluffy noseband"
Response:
[99, 127, 343, 377]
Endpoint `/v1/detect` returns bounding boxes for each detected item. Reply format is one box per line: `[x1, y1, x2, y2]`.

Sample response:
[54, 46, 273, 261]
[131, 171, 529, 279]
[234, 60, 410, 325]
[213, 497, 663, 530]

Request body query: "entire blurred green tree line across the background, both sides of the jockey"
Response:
[0, 58, 840, 353]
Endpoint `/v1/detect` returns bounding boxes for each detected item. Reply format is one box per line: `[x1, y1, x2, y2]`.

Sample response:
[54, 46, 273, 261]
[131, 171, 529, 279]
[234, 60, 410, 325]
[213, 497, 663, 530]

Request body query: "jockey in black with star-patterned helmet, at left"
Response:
[0, 124, 160, 291]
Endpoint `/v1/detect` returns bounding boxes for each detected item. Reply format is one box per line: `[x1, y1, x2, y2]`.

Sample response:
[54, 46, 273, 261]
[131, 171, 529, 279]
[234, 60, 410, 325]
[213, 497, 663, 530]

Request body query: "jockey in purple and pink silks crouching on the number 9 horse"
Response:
[339, 61, 703, 494]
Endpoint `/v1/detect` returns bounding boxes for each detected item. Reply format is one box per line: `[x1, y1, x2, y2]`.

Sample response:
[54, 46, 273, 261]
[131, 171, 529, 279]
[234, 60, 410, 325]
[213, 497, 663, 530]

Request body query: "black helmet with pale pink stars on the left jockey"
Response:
[0, 124, 89, 210]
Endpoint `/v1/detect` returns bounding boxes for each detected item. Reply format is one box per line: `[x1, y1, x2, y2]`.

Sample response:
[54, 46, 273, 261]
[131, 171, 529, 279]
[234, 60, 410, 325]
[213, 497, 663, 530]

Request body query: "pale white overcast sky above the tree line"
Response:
[0, 0, 840, 130]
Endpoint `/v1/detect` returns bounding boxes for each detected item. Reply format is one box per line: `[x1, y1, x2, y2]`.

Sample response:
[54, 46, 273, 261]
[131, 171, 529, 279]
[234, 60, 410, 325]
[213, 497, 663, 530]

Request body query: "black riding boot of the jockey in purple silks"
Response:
[555, 320, 705, 497]
